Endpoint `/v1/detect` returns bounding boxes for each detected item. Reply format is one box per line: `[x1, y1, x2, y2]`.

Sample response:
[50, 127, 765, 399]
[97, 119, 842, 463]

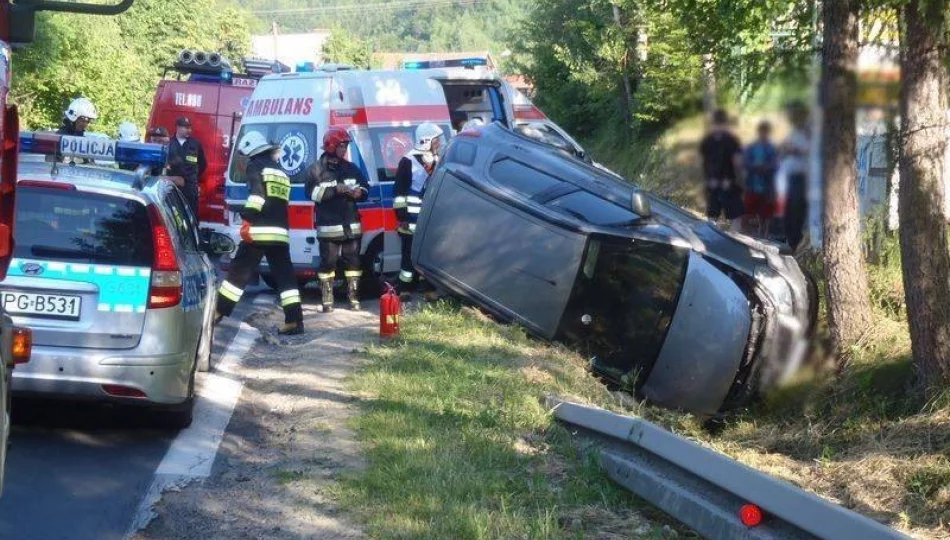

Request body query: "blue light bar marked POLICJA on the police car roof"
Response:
[20, 131, 168, 167]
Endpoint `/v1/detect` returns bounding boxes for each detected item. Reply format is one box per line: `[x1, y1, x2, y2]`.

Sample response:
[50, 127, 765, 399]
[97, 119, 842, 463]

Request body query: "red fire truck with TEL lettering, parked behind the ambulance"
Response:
[141, 50, 282, 229]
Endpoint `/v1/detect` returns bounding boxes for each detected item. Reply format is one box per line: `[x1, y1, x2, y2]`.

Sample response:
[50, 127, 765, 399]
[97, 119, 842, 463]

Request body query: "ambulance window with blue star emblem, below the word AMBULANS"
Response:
[229, 123, 320, 184]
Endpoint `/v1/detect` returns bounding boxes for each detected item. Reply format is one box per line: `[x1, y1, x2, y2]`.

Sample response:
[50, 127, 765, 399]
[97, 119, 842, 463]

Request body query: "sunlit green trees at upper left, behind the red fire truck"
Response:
[12, 0, 250, 134]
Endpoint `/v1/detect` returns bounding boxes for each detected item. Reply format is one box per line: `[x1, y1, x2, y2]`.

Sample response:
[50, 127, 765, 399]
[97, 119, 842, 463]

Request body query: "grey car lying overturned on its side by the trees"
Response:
[412, 124, 817, 415]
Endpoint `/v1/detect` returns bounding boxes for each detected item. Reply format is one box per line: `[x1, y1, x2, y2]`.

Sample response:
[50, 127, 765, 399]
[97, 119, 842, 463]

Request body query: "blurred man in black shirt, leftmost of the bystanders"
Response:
[699, 109, 745, 230]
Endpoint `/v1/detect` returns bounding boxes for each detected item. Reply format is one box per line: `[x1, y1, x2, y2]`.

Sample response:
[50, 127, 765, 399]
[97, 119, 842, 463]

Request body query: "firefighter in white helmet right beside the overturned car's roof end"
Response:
[393, 122, 445, 301]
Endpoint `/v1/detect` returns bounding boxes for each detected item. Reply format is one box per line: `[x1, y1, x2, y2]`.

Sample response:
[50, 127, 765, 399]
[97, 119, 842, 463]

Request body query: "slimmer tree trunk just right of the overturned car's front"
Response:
[821, 0, 871, 357]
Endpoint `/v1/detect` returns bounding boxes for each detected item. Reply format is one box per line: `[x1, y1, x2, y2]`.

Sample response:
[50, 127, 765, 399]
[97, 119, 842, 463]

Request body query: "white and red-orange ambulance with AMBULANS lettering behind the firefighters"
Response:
[225, 59, 552, 291]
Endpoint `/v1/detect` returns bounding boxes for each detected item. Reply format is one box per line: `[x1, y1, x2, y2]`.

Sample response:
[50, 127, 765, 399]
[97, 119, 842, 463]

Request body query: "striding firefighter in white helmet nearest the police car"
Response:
[215, 131, 303, 335]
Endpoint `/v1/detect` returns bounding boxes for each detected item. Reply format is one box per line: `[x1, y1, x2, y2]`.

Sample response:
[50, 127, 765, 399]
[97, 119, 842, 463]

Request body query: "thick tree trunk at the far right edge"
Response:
[898, 0, 950, 390]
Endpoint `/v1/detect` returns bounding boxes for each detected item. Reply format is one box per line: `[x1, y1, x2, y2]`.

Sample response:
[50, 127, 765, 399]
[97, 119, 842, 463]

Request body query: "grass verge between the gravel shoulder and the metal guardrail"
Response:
[338, 303, 676, 539]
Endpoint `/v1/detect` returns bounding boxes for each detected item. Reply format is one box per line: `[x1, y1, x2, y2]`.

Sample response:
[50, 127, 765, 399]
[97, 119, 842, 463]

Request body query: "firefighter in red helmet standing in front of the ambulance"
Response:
[306, 127, 369, 313]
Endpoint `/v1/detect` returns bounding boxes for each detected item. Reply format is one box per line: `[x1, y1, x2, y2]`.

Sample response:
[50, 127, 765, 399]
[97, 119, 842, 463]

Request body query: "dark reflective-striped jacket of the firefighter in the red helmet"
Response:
[306, 153, 369, 240]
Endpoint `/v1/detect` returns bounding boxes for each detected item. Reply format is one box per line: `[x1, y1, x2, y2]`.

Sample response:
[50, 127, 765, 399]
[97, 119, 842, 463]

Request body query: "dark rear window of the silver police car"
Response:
[15, 187, 152, 266]
